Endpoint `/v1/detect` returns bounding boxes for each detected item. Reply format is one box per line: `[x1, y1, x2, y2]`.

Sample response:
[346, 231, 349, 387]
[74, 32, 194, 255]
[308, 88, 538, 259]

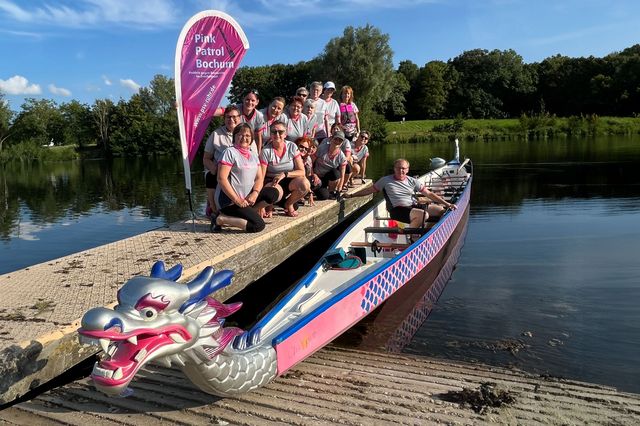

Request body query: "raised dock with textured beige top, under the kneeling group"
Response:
[0, 186, 371, 405]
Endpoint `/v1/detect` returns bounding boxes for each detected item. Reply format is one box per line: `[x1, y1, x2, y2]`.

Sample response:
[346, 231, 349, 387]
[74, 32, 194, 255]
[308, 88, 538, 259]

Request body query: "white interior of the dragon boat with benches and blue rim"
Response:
[234, 160, 471, 349]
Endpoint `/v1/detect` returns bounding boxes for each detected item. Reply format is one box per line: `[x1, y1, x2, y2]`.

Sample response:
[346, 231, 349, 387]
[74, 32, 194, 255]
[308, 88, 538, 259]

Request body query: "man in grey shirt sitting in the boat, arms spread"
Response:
[343, 158, 456, 228]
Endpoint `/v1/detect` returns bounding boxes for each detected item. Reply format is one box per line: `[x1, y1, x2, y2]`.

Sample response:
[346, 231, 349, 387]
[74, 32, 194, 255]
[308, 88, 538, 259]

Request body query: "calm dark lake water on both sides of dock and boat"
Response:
[0, 137, 640, 392]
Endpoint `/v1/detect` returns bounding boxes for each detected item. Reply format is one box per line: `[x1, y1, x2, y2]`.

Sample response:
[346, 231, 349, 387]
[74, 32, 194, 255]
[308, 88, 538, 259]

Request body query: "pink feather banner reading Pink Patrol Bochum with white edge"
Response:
[175, 10, 249, 193]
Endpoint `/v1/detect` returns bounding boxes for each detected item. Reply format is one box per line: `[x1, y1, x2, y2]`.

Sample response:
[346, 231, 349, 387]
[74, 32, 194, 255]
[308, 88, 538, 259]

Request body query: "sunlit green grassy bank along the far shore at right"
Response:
[385, 114, 640, 143]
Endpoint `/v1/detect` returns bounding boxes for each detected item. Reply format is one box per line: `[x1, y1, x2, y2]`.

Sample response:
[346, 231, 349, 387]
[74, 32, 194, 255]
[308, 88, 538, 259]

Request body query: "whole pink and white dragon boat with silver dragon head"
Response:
[78, 141, 472, 396]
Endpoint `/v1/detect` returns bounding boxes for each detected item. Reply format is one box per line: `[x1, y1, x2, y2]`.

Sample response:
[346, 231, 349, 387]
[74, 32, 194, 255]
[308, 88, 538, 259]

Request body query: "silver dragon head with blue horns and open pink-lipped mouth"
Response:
[78, 261, 242, 396]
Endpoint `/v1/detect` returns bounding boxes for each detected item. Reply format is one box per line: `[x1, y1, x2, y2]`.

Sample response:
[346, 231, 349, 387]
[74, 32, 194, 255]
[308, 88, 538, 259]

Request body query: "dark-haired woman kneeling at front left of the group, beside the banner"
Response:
[211, 123, 279, 232]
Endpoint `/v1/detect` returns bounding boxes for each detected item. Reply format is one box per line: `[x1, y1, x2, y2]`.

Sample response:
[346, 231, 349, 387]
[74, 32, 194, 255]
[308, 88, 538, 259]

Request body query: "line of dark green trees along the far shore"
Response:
[0, 25, 640, 161]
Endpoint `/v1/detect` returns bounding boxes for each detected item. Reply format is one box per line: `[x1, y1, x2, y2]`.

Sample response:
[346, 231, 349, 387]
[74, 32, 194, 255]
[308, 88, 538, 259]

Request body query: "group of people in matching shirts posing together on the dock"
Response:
[203, 81, 370, 232]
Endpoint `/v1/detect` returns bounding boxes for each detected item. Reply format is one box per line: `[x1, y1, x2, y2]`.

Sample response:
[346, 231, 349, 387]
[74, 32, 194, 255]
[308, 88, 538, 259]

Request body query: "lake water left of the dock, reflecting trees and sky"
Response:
[0, 158, 205, 273]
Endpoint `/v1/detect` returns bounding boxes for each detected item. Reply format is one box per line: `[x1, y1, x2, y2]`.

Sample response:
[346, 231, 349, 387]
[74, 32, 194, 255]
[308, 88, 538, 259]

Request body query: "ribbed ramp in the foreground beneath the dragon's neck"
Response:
[0, 346, 640, 426]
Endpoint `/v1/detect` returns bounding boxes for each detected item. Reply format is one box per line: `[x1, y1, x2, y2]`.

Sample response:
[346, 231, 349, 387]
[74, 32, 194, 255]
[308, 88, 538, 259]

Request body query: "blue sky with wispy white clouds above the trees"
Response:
[0, 0, 640, 110]
